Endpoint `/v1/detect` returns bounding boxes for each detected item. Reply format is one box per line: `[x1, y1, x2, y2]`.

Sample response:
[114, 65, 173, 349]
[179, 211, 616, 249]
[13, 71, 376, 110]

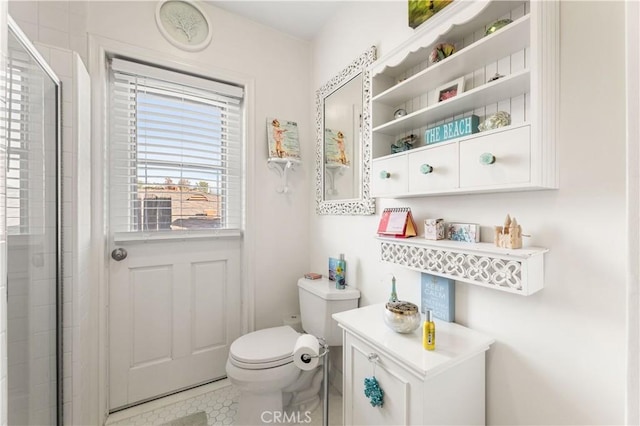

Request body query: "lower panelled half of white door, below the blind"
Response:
[109, 237, 241, 409]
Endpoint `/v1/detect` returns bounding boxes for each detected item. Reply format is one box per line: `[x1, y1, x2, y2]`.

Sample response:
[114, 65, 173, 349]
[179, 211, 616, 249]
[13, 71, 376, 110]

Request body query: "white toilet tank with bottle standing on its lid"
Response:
[298, 277, 360, 346]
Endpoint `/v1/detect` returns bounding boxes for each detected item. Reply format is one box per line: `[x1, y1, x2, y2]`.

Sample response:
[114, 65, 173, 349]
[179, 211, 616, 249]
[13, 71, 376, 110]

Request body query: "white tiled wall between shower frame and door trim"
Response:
[3, 1, 98, 424]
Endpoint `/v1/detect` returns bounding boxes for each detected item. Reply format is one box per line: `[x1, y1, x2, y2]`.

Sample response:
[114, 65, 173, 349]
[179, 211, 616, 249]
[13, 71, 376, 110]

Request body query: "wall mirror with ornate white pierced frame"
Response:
[316, 46, 376, 215]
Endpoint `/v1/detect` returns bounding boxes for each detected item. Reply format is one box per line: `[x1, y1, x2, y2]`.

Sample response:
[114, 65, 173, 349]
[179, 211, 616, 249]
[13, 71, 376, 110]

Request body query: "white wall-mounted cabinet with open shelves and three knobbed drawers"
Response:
[371, 0, 559, 198]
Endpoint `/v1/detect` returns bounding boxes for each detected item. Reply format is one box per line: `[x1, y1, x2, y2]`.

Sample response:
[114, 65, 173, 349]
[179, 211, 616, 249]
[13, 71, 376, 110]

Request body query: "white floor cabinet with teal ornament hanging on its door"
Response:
[333, 305, 494, 425]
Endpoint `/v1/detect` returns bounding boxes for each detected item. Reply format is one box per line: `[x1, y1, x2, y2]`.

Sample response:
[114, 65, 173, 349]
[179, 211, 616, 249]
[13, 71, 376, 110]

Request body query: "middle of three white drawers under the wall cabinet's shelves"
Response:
[408, 143, 458, 193]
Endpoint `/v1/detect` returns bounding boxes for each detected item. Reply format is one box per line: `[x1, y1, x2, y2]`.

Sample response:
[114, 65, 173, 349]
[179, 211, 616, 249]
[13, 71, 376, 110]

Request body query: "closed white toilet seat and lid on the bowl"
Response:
[229, 326, 300, 370]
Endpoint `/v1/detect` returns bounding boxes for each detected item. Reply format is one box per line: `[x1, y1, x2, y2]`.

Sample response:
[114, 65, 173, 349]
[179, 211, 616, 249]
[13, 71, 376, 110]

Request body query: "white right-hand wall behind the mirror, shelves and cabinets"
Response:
[309, 2, 627, 424]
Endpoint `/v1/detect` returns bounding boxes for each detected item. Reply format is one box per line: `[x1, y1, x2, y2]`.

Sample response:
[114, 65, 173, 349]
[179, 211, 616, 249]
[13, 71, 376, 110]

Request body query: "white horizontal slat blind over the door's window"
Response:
[109, 59, 243, 233]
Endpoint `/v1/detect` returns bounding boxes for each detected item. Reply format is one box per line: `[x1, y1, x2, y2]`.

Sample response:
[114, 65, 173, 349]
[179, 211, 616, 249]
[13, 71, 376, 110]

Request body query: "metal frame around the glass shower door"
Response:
[7, 15, 63, 425]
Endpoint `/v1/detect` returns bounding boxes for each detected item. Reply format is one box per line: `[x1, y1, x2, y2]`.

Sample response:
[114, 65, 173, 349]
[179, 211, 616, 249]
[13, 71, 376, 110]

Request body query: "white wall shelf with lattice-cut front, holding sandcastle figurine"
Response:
[378, 238, 548, 296]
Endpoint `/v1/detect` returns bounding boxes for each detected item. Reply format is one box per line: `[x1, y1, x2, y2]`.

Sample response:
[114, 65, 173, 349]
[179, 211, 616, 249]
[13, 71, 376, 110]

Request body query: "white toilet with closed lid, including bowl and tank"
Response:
[226, 277, 360, 425]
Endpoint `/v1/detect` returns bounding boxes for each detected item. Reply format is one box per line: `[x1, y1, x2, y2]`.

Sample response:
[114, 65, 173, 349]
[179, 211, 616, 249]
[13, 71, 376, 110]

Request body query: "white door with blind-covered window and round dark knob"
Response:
[107, 58, 243, 410]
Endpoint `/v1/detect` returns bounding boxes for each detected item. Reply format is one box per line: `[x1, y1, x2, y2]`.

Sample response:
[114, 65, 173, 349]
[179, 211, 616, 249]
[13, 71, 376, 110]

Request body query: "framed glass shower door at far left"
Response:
[4, 20, 62, 425]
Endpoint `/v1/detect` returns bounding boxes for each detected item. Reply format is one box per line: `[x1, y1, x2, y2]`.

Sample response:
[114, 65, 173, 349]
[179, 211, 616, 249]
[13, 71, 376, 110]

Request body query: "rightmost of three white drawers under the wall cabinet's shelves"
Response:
[460, 126, 531, 189]
